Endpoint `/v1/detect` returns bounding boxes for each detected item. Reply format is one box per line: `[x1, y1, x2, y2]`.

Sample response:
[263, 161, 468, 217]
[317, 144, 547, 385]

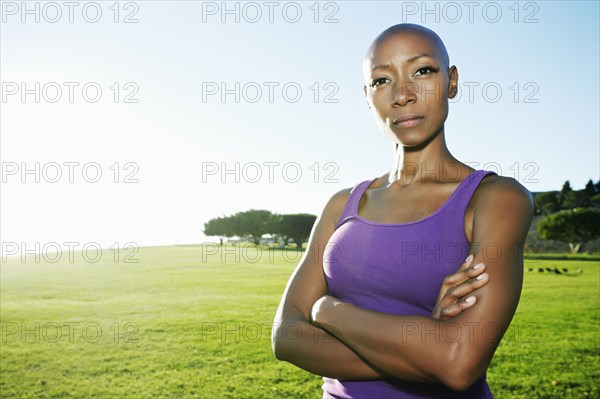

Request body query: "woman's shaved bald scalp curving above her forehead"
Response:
[363, 23, 450, 83]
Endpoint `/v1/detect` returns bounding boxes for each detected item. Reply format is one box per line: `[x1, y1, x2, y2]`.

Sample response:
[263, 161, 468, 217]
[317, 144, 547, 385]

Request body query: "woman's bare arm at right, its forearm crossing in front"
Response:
[312, 178, 533, 390]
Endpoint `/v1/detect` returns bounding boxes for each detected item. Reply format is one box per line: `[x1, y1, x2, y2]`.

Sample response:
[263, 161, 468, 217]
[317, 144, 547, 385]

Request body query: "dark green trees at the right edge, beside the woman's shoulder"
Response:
[533, 180, 600, 253]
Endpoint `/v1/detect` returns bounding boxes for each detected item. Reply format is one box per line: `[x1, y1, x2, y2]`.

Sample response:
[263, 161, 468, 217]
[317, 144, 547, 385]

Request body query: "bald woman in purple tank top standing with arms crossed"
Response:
[273, 24, 533, 398]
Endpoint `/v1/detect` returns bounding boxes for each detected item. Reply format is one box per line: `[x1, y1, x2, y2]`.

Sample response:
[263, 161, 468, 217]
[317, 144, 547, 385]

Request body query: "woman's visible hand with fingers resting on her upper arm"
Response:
[431, 255, 489, 320]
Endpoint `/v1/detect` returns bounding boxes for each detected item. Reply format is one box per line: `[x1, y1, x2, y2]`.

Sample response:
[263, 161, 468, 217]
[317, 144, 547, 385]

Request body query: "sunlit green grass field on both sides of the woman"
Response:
[0, 246, 600, 399]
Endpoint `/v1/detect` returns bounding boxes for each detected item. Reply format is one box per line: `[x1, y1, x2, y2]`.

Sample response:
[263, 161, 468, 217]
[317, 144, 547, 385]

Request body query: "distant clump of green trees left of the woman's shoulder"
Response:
[204, 209, 317, 249]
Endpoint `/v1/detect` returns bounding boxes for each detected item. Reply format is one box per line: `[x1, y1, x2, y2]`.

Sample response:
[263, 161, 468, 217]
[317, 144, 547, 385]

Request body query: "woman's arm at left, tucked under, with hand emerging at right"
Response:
[272, 189, 487, 380]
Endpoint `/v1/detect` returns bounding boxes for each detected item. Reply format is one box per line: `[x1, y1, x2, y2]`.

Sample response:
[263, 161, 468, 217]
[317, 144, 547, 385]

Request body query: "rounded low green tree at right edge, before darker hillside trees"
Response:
[537, 208, 600, 253]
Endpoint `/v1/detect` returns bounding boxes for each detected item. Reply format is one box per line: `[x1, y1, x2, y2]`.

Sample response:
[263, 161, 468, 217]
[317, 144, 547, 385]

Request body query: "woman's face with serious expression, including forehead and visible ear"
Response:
[364, 31, 458, 149]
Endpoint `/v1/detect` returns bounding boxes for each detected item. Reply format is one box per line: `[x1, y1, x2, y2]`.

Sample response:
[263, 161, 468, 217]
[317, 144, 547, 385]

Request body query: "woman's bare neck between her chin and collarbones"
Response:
[388, 131, 463, 185]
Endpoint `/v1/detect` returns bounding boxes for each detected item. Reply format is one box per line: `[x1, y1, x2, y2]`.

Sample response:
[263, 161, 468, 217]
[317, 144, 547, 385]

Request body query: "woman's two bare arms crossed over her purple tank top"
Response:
[273, 178, 533, 390]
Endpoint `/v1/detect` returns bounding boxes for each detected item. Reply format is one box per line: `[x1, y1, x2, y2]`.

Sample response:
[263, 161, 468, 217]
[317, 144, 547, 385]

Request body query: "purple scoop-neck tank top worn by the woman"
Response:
[323, 170, 494, 399]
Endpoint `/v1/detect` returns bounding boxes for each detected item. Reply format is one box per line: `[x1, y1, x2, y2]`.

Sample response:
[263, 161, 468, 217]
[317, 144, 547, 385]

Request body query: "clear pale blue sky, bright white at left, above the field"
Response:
[0, 1, 600, 253]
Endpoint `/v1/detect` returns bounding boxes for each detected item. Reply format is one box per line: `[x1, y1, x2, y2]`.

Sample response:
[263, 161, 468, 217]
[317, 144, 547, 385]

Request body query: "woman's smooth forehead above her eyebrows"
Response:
[364, 31, 442, 73]
